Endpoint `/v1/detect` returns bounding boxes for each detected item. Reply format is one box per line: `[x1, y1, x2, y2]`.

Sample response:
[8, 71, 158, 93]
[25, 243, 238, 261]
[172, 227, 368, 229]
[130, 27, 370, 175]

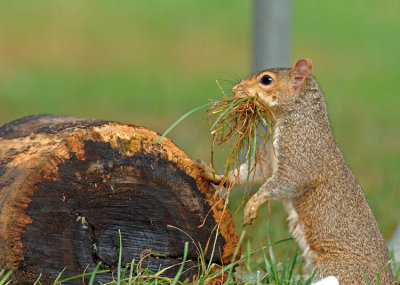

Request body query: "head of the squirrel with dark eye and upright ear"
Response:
[232, 58, 312, 109]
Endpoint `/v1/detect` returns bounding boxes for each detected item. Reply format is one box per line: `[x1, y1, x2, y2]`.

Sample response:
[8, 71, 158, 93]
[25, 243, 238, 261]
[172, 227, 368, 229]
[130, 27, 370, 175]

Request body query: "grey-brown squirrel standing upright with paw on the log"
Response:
[200, 58, 400, 284]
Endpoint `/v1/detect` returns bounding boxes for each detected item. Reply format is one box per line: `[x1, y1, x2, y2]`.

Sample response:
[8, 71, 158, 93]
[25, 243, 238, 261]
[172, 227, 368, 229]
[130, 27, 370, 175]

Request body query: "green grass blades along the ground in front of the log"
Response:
[0, 229, 314, 285]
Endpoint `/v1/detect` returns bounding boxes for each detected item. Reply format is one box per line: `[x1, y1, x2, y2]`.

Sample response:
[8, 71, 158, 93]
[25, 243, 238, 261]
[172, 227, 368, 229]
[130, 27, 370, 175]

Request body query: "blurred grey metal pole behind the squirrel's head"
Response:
[252, 0, 292, 72]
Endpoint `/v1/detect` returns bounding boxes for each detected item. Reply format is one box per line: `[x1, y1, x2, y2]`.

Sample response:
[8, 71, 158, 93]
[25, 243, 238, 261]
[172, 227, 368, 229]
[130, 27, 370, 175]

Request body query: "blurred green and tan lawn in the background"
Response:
[0, 0, 400, 258]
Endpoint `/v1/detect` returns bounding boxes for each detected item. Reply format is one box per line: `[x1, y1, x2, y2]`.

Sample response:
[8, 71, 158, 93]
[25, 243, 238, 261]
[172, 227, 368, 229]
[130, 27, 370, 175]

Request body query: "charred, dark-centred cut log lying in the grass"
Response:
[0, 115, 238, 284]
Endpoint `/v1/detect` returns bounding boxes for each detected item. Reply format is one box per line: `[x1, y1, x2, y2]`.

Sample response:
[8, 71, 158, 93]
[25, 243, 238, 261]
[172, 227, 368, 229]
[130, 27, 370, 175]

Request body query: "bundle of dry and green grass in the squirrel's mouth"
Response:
[206, 96, 274, 180]
